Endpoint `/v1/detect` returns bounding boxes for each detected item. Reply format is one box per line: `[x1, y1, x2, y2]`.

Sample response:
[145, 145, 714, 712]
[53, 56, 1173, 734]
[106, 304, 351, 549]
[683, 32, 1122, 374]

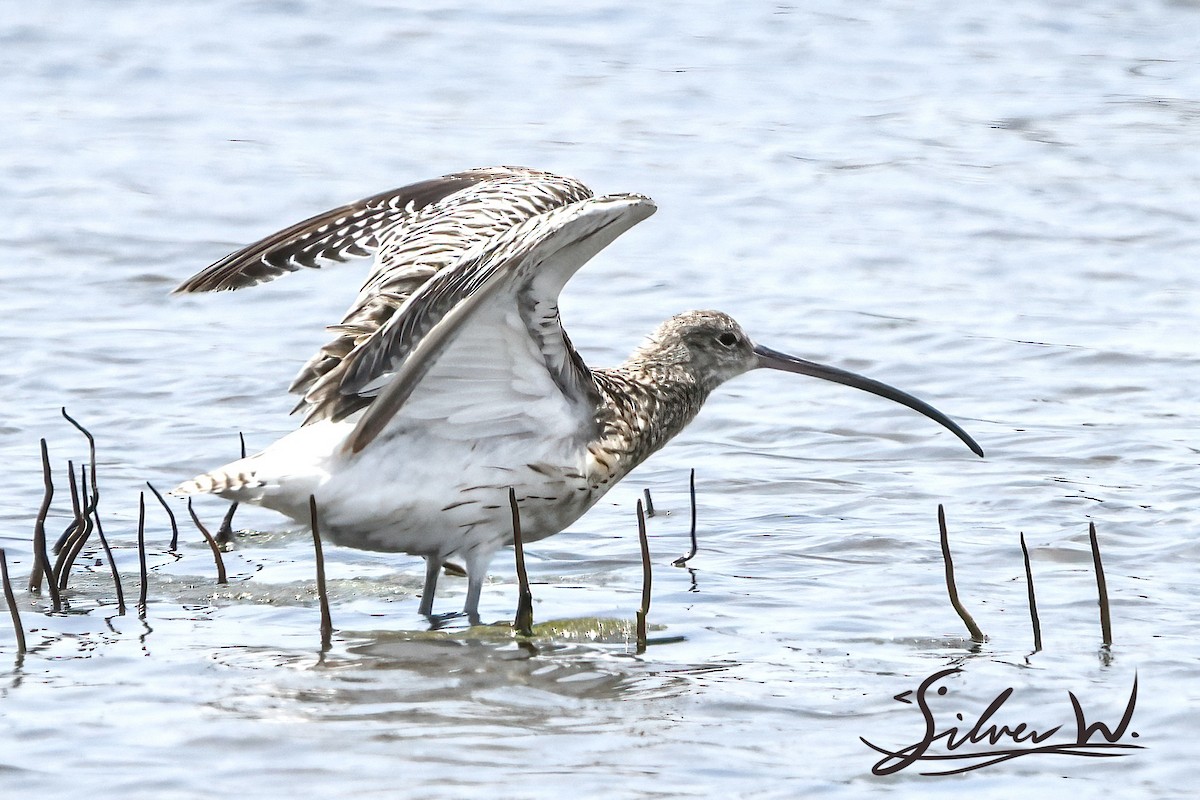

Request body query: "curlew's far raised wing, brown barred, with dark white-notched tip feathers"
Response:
[175, 167, 592, 423]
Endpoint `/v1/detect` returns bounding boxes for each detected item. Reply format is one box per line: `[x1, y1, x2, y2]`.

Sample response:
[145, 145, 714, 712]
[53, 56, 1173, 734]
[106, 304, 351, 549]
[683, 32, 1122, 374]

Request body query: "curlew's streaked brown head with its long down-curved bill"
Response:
[630, 311, 983, 457]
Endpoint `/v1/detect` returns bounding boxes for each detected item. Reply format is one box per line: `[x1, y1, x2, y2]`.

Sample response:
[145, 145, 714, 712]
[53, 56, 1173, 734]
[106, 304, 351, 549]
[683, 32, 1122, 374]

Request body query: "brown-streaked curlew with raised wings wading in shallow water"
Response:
[175, 167, 983, 622]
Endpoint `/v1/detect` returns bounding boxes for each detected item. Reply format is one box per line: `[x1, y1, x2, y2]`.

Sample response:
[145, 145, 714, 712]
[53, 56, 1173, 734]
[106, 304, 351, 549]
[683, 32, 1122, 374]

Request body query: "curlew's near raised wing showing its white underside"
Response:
[338, 194, 655, 452]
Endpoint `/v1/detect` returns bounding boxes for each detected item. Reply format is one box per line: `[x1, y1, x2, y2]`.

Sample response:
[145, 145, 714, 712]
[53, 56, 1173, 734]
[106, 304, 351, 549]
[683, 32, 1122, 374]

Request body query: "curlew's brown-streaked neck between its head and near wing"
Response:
[593, 359, 709, 479]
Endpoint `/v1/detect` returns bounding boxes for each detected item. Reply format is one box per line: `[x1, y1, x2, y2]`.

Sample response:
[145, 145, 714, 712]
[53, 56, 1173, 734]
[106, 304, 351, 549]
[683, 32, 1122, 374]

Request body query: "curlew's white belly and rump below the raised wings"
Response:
[238, 422, 616, 559]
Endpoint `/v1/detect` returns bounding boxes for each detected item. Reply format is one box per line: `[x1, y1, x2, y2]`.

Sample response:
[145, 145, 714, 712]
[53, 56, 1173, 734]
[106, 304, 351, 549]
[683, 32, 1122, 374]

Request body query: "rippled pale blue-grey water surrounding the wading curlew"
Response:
[0, 0, 1200, 799]
